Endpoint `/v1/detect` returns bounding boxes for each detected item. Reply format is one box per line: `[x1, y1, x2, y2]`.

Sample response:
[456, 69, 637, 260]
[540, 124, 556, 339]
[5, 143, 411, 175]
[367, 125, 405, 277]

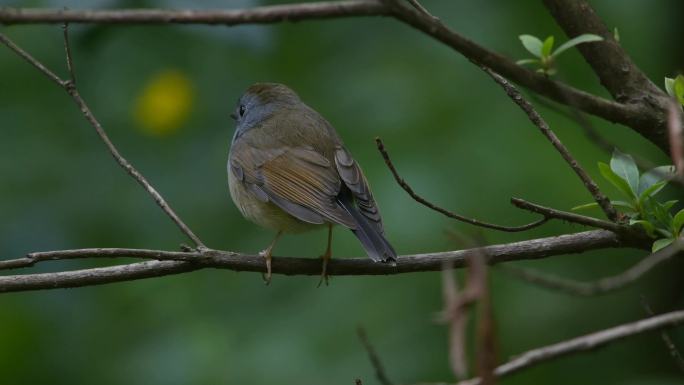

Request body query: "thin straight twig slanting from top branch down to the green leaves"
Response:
[480, 66, 618, 222]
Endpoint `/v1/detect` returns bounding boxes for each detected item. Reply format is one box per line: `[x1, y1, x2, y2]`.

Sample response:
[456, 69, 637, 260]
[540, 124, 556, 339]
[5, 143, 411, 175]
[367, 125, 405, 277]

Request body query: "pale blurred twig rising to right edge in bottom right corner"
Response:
[457, 310, 684, 385]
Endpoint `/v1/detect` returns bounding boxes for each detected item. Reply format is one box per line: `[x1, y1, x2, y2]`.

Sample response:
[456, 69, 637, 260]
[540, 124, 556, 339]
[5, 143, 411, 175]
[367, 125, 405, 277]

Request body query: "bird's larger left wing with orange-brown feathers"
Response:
[231, 147, 356, 229]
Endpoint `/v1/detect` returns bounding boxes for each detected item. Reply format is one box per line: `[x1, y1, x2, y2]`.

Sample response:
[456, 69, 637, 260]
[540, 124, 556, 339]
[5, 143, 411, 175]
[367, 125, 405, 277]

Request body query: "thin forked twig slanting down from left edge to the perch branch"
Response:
[0, 25, 206, 248]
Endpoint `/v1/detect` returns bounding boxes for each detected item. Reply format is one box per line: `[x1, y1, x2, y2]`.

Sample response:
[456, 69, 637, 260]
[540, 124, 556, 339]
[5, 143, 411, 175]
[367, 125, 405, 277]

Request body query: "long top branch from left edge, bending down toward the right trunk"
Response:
[0, 0, 668, 151]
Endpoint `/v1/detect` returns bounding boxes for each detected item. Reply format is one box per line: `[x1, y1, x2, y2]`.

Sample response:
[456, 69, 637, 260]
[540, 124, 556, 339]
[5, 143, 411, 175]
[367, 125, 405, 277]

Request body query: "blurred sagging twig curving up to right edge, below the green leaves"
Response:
[500, 236, 684, 296]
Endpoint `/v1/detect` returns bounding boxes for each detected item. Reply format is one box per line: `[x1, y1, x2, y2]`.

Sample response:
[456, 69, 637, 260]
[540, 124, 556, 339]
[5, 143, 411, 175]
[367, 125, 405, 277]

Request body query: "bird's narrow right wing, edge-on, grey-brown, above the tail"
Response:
[335, 145, 384, 234]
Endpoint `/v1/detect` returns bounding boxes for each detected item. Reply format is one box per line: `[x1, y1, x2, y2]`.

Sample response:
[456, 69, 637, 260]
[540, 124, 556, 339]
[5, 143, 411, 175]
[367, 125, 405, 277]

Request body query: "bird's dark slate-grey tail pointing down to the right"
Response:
[339, 199, 397, 264]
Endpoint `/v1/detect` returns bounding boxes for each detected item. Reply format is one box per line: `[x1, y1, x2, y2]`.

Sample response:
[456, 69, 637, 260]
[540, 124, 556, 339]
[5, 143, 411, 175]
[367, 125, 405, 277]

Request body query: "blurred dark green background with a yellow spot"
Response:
[0, 0, 684, 385]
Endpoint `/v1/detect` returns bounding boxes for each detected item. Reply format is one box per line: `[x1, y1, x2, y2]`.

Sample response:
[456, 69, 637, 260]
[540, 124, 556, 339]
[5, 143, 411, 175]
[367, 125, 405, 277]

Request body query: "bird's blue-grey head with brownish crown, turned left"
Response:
[230, 83, 301, 142]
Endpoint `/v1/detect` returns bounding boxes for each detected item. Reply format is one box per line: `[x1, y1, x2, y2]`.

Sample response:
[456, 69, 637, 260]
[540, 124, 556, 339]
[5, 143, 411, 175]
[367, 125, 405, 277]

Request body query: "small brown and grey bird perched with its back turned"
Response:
[228, 83, 397, 285]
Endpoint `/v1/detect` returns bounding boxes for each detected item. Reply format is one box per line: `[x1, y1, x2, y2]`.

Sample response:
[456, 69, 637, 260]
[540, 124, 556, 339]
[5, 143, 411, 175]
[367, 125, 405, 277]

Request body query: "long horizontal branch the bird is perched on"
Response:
[0, 230, 647, 292]
